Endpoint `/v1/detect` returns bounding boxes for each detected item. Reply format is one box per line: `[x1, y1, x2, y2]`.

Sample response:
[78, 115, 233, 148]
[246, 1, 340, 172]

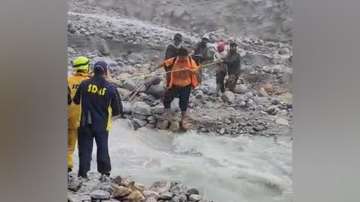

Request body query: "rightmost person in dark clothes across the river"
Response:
[223, 42, 241, 92]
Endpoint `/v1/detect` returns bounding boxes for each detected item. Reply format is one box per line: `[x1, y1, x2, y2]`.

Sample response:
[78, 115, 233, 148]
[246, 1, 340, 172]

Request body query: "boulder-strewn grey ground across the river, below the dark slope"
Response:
[68, 10, 292, 136]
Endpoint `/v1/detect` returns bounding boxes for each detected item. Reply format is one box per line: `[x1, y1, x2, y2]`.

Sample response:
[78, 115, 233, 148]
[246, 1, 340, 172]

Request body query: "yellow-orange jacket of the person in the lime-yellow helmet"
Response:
[68, 72, 89, 129]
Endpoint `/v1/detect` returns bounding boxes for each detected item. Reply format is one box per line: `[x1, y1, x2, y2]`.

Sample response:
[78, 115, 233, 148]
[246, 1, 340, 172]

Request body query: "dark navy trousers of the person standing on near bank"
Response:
[78, 125, 111, 177]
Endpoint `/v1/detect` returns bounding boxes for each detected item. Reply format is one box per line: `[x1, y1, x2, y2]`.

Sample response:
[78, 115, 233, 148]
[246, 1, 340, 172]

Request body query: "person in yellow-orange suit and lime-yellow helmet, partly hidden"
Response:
[67, 56, 90, 172]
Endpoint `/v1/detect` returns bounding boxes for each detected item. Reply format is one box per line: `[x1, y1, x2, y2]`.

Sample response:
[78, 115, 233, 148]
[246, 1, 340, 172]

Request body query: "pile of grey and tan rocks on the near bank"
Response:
[68, 175, 210, 202]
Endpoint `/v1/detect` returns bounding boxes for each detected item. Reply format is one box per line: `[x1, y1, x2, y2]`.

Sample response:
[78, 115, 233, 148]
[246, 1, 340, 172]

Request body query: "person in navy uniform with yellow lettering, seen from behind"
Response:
[73, 61, 123, 181]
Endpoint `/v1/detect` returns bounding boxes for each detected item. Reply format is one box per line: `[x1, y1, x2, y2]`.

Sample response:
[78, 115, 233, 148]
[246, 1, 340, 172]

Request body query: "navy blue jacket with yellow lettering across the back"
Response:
[73, 76, 123, 130]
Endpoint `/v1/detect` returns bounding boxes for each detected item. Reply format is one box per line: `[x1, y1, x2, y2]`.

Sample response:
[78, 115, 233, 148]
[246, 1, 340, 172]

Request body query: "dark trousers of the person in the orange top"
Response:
[163, 85, 191, 112]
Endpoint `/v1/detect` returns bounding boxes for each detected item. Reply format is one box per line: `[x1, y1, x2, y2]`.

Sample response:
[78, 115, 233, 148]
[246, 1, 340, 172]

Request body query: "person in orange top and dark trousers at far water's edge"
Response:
[160, 47, 200, 129]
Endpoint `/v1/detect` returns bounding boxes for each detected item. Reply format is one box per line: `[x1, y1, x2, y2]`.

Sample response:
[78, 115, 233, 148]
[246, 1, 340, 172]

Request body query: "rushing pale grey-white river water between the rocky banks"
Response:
[76, 120, 292, 202]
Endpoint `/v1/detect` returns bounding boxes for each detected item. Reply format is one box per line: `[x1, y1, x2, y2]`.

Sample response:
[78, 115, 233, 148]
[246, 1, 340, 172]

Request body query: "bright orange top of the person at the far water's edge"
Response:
[161, 57, 200, 88]
